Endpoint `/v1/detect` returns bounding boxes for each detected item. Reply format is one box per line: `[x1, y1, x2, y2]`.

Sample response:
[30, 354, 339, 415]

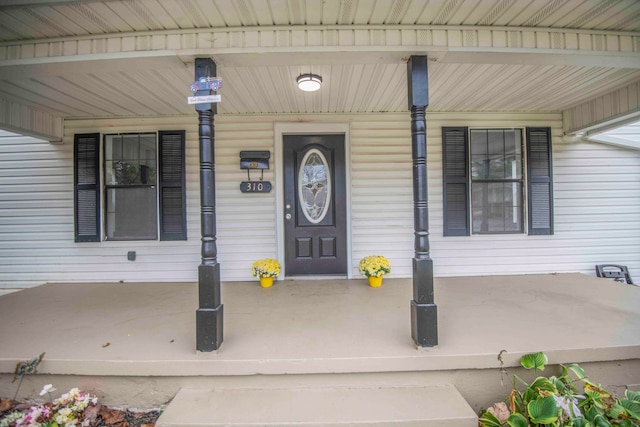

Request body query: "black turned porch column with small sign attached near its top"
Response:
[195, 58, 223, 351]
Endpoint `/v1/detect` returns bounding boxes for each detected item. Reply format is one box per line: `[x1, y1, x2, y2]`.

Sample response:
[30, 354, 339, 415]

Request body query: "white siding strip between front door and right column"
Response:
[350, 113, 414, 278]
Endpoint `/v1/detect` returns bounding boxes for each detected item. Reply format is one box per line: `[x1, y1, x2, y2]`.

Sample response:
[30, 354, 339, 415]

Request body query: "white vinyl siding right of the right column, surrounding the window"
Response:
[427, 114, 640, 277]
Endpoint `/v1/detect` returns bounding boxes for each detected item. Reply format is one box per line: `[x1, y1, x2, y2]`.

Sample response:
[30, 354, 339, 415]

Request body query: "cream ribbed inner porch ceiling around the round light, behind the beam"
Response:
[0, 58, 640, 117]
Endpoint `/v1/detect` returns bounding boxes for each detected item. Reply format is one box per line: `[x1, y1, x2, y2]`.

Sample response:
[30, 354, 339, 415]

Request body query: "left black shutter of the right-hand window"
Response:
[442, 127, 470, 236]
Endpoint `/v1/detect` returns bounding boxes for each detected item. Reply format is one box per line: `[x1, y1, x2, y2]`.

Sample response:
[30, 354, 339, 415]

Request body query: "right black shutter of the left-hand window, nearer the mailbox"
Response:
[159, 131, 187, 240]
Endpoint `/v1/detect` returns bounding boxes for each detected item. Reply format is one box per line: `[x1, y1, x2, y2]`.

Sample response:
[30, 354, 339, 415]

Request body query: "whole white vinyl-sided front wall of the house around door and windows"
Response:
[0, 113, 640, 293]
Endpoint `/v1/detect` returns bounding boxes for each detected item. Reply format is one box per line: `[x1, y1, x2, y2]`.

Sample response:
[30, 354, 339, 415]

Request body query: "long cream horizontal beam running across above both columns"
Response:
[0, 25, 640, 68]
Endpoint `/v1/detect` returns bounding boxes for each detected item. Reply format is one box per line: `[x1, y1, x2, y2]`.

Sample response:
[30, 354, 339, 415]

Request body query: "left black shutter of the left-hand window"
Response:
[73, 133, 100, 242]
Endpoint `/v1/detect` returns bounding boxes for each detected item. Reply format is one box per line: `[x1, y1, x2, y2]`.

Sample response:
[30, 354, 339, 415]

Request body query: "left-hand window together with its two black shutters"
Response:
[74, 131, 187, 242]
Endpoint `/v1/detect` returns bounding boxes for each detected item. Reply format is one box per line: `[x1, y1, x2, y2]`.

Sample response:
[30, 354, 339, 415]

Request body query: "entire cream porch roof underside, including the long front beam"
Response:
[0, 0, 640, 144]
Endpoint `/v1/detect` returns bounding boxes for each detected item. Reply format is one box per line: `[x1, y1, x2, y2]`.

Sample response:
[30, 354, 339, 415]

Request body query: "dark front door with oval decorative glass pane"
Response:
[282, 134, 347, 276]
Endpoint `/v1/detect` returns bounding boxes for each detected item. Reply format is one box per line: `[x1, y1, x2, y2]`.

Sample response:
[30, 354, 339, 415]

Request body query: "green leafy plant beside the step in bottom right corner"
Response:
[478, 353, 640, 427]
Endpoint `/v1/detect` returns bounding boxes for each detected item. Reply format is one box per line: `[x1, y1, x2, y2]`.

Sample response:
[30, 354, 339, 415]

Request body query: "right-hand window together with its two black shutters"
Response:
[442, 127, 553, 236]
